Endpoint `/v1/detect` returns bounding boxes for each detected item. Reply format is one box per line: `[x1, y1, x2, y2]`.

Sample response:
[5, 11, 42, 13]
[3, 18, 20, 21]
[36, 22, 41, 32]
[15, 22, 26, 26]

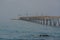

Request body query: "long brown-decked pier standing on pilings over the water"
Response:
[19, 16, 60, 26]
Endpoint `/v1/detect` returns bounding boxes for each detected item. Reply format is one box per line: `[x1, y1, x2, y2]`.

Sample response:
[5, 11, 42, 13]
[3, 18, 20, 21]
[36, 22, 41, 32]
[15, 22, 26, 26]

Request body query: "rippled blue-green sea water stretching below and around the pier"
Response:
[0, 20, 60, 40]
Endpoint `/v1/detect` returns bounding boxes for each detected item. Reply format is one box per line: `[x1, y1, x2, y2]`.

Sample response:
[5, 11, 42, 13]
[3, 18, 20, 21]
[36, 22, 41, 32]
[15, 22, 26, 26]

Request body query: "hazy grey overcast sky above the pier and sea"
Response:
[0, 0, 60, 20]
